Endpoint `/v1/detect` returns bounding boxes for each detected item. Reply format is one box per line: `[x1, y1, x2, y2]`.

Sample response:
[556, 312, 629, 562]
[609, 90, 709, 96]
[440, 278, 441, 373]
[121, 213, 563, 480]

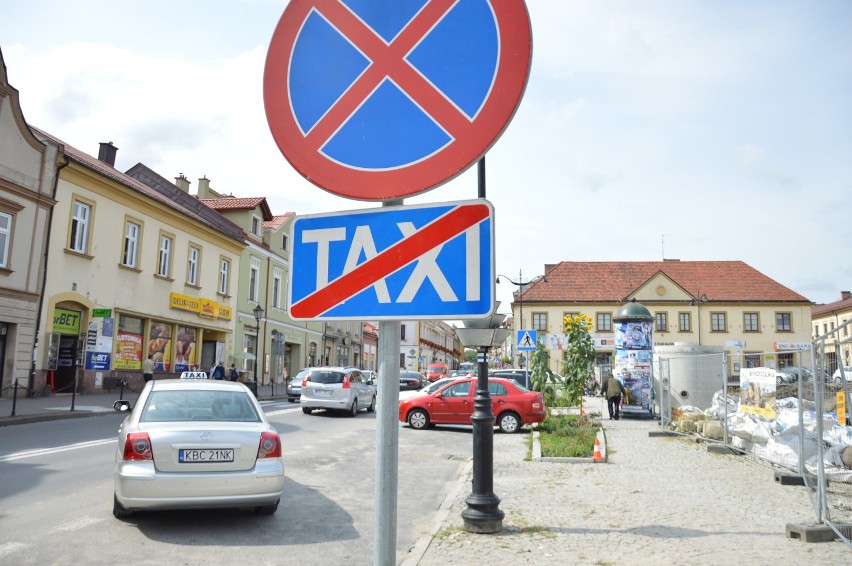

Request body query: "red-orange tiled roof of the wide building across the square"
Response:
[523, 261, 811, 303]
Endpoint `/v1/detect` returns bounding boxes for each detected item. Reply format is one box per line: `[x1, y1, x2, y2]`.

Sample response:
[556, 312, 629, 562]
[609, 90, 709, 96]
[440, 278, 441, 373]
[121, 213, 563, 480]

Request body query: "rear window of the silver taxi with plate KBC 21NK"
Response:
[139, 389, 260, 423]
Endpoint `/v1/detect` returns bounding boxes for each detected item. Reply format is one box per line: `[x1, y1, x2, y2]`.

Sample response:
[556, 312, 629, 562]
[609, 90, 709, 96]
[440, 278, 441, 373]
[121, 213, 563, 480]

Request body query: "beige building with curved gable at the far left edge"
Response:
[0, 47, 59, 397]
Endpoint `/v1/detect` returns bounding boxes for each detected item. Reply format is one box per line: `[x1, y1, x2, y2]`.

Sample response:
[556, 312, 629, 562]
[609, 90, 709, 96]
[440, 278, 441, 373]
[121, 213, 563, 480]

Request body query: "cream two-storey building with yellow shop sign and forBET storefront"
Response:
[35, 132, 245, 391]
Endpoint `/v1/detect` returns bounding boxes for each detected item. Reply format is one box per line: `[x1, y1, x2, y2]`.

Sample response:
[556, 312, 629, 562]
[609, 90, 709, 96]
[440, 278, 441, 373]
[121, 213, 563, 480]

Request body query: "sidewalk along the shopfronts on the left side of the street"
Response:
[0, 384, 287, 427]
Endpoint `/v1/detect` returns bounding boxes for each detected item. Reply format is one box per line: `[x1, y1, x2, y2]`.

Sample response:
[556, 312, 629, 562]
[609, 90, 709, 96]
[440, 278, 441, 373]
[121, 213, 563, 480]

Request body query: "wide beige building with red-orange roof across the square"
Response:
[509, 260, 812, 378]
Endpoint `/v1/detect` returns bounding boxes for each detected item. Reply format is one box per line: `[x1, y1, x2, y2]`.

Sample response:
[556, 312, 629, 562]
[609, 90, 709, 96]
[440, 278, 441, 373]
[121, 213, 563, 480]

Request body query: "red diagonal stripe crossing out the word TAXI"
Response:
[290, 204, 489, 318]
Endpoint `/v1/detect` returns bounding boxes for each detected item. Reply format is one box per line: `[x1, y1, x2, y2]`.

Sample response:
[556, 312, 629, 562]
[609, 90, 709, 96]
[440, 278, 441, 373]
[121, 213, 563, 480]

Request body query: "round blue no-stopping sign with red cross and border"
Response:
[263, 0, 532, 201]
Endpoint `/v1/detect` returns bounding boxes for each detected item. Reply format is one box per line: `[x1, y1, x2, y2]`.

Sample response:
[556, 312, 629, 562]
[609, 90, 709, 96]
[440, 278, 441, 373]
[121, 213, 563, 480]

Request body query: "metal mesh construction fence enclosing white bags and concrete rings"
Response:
[654, 344, 852, 548]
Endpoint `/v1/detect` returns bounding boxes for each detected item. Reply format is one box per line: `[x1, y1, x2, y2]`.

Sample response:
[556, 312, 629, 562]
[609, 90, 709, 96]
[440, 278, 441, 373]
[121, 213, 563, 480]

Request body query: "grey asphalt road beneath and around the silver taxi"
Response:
[0, 401, 472, 565]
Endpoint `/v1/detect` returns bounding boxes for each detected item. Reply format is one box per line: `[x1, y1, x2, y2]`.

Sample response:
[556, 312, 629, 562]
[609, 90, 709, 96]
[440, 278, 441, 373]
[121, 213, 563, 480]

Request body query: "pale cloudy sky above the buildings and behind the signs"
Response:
[0, 0, 852, 320]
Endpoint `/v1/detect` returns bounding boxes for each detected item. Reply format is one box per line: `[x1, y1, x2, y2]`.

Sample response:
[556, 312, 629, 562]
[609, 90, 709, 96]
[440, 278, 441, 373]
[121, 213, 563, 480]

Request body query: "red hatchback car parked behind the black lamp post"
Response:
[399, 377, 547, 433]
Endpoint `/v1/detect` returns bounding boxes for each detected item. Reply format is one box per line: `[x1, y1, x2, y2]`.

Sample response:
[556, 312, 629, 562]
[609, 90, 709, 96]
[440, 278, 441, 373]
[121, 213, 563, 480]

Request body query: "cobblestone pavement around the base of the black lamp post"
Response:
[400, 418, 852, 566]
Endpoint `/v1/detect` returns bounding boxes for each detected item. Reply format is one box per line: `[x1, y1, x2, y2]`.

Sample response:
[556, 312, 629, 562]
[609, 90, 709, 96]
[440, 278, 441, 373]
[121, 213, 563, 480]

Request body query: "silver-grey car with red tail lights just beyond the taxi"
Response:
[299, 367, 376, 417]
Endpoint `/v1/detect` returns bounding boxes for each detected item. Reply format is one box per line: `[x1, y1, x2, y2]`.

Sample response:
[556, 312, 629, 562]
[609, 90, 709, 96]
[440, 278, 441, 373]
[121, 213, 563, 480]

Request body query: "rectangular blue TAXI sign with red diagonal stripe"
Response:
[288, 199, 495, 320]
